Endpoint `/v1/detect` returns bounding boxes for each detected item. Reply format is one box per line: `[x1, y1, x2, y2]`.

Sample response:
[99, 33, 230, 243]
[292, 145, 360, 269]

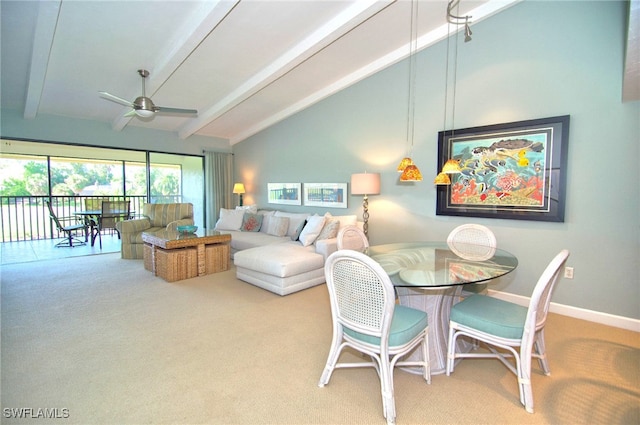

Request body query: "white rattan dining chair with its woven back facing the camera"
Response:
[318, 250, 431, 424]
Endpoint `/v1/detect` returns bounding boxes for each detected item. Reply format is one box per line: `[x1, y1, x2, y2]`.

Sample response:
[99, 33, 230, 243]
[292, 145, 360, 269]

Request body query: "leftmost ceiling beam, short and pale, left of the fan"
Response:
[24, 0, 62, 119]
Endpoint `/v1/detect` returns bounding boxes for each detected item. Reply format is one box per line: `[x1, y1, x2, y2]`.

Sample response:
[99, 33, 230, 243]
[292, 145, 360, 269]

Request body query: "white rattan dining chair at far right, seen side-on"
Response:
[447, 249, 569, 413]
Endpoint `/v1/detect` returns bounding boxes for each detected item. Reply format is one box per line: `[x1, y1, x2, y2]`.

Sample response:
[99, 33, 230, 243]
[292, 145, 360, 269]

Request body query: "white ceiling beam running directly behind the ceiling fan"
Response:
[112, 0, 240, 131]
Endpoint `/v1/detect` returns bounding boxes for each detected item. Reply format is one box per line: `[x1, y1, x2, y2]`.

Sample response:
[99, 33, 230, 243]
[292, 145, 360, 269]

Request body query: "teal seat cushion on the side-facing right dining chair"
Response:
[450, 295, 527, 339]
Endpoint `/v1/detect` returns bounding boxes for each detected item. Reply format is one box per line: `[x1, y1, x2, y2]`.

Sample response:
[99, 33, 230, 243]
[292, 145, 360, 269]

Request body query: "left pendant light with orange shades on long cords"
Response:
[398, 0, 422, 182]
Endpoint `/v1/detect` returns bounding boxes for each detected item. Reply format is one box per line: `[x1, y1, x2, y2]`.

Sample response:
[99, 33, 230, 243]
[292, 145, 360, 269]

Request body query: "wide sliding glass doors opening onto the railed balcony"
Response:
[0, 139, 205, 242]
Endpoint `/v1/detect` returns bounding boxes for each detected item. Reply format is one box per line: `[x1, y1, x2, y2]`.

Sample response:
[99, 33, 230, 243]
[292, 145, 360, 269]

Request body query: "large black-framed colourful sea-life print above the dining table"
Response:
[436, 115, 569, 222]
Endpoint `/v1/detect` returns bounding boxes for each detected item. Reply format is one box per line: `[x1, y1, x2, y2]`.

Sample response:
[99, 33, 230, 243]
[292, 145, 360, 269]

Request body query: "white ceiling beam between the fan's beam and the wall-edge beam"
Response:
[178, 0, 396, 139]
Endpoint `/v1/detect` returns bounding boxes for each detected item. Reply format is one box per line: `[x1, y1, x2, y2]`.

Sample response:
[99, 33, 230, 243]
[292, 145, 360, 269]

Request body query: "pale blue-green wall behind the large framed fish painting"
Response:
[233, 1, 640, 319]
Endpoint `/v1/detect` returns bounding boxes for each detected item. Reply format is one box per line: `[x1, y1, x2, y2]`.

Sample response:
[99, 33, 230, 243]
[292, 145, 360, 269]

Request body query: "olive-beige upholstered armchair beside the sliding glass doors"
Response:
[116, 203, 193, 259]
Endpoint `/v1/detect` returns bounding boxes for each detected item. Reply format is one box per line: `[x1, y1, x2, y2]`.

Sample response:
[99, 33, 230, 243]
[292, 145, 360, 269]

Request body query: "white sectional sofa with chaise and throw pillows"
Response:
[216, 206, 362, 295]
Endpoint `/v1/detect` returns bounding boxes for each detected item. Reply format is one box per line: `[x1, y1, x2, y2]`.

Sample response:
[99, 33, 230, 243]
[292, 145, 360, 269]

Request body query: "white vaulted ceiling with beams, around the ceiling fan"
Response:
[0, 0, 636, 144]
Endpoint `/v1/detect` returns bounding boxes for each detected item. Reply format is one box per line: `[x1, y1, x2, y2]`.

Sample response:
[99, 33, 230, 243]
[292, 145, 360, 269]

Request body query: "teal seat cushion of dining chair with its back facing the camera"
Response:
[344, 305, 428, 347]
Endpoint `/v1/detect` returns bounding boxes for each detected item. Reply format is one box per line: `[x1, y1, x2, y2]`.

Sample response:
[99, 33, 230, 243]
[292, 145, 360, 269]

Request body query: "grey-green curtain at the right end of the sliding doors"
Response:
[204, 152, 233, 229]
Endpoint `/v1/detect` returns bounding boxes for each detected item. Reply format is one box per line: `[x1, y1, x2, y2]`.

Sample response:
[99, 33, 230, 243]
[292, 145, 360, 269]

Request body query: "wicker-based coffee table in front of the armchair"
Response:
[142, 229, 231, 282]
